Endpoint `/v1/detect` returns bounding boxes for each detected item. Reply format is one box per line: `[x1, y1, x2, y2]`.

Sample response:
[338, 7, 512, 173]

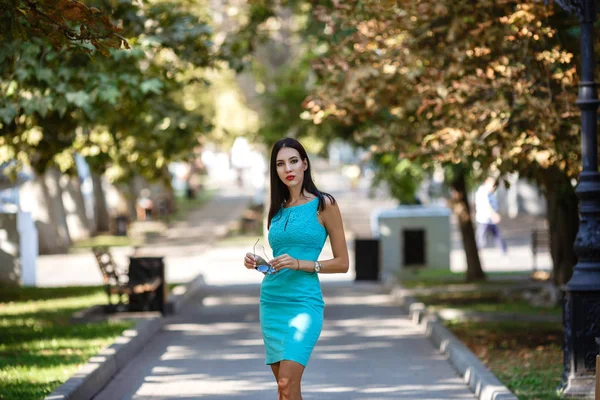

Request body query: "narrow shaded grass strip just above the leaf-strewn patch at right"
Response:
[415, 291, 562, 316]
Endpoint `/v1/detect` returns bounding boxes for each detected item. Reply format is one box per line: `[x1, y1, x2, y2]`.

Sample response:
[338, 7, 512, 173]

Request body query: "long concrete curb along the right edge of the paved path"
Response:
[384, 279, 518, 400]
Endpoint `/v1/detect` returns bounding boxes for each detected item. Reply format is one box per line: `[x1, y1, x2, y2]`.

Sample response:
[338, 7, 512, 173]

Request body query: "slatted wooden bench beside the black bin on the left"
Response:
[92, 247, 162, 312]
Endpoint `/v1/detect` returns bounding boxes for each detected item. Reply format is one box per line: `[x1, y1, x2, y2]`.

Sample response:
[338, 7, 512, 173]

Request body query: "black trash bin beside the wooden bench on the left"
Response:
[127, 257, 167, 314]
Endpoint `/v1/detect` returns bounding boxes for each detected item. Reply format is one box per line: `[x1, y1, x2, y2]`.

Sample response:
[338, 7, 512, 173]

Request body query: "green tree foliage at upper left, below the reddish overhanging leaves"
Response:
[0, 2, 214, 250]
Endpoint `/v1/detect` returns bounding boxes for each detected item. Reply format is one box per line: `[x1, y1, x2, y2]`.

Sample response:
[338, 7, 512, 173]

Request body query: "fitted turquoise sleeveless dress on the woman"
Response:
[260, 198, 327, 367]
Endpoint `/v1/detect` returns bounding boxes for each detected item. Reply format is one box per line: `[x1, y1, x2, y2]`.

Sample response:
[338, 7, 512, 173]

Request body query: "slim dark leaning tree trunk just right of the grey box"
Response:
[450, 167, 485, 282]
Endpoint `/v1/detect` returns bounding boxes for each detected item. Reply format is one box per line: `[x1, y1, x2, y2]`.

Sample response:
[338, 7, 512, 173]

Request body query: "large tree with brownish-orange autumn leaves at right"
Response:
[305, 0, 579, 283]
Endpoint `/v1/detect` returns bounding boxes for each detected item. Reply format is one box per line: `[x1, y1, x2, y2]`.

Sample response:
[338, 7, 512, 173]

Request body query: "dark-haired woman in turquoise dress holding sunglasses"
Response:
[244, 138, 348, 400]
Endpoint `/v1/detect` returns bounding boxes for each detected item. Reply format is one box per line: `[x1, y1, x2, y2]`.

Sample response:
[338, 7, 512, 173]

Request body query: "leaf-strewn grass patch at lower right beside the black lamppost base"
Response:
[446, 322, 563, 400]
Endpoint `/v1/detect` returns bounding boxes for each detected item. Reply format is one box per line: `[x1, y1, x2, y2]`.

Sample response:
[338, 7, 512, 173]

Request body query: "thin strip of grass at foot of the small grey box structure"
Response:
[398, 268, 530, 289]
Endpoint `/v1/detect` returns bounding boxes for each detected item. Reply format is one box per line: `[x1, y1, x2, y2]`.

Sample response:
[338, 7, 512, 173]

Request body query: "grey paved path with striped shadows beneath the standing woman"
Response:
[94, 282, 474, 400]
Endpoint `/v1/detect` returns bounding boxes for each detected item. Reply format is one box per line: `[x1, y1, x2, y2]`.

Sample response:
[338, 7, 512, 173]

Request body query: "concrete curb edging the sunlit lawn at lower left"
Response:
[44, 316, 161, 400]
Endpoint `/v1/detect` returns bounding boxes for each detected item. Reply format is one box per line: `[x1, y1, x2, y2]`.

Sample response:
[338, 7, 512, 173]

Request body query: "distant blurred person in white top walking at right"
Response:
[475, 177, 508, 254]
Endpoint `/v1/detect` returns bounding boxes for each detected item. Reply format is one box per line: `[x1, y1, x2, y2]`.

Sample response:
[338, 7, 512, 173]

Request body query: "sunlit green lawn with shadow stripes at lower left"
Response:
[0, 287, 134, 400]
